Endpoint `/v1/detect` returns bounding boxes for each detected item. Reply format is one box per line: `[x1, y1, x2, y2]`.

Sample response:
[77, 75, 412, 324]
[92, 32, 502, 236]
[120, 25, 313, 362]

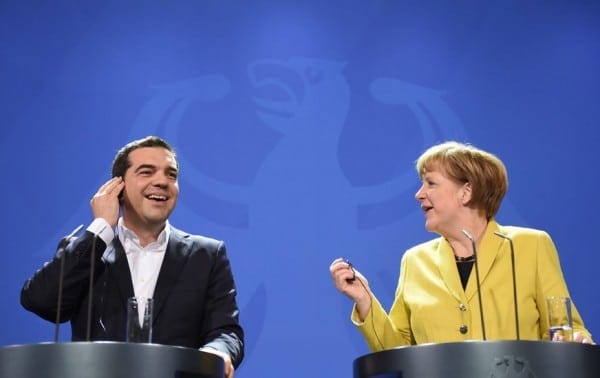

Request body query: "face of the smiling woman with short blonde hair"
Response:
[415, 168, 469, 235]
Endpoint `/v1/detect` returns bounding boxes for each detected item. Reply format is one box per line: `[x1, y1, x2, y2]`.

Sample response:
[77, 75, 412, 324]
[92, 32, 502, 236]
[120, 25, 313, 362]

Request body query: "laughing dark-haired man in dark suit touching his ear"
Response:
[21, 136, 244, 378]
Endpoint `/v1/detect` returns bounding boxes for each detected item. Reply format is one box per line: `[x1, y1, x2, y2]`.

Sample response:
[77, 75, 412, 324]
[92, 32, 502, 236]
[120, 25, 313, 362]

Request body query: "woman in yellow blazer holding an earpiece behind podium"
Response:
[330, 142, 592, 351]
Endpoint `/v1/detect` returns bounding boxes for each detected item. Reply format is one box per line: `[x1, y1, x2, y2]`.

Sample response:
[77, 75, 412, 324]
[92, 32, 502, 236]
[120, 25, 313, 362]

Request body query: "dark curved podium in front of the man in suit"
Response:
[0, 341, 223, 378]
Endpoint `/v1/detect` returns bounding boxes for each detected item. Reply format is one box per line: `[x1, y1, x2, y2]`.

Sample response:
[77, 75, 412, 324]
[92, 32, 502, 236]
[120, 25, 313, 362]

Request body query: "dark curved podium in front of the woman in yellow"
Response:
[354, 341, 600, 378]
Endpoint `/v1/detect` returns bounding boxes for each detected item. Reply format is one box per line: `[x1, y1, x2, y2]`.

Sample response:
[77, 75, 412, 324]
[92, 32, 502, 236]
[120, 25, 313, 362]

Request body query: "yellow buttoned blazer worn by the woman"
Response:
[351, 220, 591, 351]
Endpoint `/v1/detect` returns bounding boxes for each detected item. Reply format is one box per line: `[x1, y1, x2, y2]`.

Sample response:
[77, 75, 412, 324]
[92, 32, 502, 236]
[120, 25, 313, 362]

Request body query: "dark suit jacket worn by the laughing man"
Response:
[21, 227, 244, 367]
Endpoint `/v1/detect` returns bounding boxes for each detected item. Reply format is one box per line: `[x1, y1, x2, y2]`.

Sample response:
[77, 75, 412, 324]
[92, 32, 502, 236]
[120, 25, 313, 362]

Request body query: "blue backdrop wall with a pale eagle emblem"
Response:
[0, 0, 600, 378]
